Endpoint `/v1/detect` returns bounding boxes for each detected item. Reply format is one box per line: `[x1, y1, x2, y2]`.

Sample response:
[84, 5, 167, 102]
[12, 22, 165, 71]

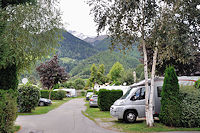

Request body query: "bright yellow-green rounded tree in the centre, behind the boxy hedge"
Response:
[108, 62, 124, 85]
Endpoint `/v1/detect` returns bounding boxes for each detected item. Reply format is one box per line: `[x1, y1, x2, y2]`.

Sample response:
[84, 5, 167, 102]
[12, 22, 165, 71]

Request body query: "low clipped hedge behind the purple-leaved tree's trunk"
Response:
[40, 90, 66, 100]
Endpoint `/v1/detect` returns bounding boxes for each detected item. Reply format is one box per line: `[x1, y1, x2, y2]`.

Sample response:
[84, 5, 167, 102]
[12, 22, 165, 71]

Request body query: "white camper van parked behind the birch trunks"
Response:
[110, 76, 200, 123]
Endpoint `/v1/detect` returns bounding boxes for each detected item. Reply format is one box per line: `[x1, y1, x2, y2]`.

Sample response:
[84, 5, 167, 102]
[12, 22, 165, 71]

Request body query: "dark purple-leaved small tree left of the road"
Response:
[36, 56, 69, 99]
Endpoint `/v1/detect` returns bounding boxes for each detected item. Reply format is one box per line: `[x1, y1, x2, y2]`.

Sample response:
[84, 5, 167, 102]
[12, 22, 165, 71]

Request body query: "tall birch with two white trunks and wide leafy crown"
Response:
[89, 0, 199, 126]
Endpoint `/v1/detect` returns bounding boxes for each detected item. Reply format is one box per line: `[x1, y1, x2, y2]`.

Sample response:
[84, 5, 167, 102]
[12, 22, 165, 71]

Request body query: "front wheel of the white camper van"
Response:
[124, 110, 137, 123]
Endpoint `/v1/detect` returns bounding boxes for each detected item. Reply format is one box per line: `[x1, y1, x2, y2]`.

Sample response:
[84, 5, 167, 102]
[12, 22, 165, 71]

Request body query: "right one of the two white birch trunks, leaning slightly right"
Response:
[148, 47, 158, 127]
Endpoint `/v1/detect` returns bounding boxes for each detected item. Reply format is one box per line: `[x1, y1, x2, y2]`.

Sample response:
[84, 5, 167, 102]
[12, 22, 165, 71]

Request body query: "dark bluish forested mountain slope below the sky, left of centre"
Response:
[58, 31, 99, 60]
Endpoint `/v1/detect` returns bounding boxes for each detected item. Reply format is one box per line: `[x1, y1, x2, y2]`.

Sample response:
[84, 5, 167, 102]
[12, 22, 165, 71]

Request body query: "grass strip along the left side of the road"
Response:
[18, 98, 73, 115]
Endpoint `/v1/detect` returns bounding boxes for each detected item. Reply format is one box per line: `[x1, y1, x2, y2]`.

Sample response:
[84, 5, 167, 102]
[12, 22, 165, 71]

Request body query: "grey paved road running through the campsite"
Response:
[16, 99, 120, 133]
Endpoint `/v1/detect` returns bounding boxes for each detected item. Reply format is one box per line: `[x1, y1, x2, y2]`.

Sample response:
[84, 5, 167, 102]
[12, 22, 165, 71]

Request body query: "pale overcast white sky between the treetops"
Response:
[60, 0, 97, 36]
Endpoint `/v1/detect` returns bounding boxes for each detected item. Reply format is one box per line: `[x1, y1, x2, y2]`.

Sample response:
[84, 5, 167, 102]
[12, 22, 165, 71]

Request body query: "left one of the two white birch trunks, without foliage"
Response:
[142, 39, 149, 125]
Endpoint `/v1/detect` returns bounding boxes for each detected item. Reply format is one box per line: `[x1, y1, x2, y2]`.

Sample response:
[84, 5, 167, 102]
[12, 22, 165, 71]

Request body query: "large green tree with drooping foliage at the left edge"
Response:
[0, 0, 62, 89]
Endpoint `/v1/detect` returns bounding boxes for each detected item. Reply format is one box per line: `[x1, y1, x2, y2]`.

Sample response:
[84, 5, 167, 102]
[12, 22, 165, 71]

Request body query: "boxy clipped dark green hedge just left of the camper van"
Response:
[98, 89, 123, 111]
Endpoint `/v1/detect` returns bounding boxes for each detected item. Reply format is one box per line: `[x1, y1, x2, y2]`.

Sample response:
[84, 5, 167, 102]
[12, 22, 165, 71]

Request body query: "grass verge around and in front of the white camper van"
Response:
[83, 103, 200, 133]
